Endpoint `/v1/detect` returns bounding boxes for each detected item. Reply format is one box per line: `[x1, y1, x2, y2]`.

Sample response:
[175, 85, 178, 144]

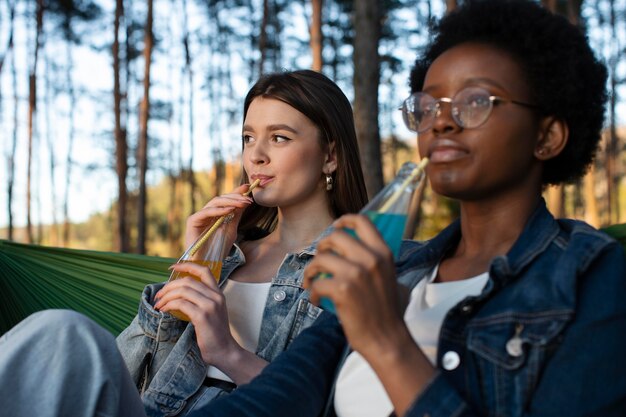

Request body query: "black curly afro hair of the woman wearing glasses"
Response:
[410, 0, 607, 185]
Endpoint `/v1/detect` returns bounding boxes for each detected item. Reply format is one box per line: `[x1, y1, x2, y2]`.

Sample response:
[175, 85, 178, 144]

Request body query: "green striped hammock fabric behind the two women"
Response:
[0, 224, 626, 335]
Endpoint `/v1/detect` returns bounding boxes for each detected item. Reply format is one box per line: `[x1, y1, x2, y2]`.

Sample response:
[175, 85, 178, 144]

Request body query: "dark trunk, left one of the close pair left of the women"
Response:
[112, 0, 130, 252]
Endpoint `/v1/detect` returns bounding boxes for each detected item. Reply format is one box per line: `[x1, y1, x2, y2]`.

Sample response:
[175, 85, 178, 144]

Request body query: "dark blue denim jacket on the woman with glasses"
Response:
[198, 203, 626, 417]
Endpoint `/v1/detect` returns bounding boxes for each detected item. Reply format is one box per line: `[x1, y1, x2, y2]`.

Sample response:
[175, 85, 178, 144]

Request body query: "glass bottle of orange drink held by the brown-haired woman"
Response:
[168, 180, 260, 321]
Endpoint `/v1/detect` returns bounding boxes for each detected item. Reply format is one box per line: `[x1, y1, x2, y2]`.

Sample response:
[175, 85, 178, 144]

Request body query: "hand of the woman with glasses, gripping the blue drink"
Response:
[304, 215, 403, 354]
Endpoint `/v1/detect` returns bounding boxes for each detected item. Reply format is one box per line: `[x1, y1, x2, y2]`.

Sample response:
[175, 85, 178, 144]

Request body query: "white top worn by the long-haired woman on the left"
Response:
[207, 279, 272, 382]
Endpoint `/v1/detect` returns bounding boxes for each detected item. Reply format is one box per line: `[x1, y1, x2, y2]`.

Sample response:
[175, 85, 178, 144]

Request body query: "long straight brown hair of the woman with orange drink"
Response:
[239, 70, 367, 240]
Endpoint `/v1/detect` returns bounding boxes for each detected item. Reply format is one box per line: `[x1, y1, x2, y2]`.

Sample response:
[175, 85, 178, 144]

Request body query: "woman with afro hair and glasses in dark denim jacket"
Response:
[0, 0, 626, 417]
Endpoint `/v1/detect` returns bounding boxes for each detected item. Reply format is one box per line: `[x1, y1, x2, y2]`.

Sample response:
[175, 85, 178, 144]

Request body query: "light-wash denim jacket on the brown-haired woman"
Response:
[117, 230, 329, 417]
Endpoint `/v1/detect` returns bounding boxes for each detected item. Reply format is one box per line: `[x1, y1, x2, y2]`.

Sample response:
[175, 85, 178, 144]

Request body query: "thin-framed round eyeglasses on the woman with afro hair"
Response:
[400, 87, 537, 133]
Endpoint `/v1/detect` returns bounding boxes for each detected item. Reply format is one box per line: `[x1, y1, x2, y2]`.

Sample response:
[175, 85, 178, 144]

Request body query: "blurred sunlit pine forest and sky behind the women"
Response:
[0, 0, 626, 257]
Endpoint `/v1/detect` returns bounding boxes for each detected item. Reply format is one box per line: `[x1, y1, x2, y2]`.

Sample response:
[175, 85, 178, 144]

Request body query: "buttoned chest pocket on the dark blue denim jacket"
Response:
[467, 311, 573, 417]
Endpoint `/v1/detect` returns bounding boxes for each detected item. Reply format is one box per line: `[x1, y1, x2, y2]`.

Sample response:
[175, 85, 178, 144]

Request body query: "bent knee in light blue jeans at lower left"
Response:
[0, 310, 146, 417]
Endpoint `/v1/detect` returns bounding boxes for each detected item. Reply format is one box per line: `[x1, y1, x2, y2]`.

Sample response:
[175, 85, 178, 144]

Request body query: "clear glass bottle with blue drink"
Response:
[318, 158, 428, 313]
